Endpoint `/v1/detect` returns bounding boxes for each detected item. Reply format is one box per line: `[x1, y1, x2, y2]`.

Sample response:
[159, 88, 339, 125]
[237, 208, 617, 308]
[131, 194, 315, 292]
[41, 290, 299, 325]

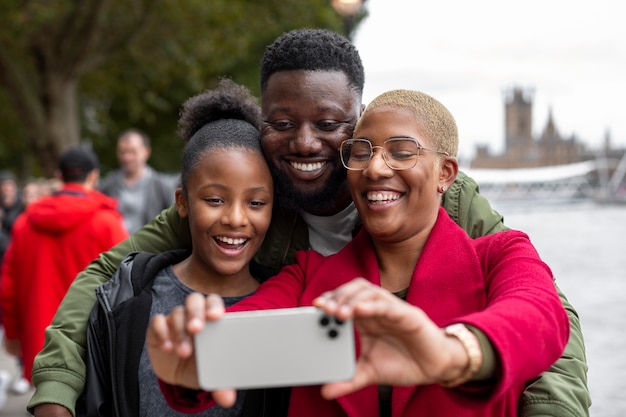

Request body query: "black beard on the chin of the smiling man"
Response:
[270, 166, 347, 214]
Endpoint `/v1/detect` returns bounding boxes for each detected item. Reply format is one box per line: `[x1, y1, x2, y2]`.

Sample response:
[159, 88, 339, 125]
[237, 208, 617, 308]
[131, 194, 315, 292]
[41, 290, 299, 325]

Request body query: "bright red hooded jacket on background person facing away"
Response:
[0, 184, 128, 379]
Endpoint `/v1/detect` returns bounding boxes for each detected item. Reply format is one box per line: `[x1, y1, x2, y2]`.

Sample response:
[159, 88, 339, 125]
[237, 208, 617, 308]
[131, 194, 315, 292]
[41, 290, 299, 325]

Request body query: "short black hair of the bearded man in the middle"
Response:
[261, 29, 365, 97]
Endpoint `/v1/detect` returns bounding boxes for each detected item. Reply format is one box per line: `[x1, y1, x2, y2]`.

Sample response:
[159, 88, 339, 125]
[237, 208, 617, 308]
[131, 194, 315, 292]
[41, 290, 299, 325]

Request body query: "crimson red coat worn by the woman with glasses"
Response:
[162, 209, 569, 417]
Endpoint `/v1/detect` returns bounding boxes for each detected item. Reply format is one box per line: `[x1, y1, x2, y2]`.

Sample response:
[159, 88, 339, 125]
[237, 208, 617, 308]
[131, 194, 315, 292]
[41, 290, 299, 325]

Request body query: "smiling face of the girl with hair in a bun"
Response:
[176, 149, 274, 276]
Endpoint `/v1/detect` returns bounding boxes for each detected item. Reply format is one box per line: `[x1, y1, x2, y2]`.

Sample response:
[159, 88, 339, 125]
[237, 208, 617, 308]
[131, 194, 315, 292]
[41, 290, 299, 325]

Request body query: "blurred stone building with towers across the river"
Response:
[471, 87, 588, 169]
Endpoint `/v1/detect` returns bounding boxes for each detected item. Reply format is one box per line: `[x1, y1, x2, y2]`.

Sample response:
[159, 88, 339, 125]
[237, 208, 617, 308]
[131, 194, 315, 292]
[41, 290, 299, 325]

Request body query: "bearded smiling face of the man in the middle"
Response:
[261, 70, 361, 215]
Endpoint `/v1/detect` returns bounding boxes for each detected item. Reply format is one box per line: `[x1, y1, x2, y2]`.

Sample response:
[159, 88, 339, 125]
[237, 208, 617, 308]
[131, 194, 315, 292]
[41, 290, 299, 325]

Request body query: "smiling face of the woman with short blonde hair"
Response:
[348, 106, 454, 243]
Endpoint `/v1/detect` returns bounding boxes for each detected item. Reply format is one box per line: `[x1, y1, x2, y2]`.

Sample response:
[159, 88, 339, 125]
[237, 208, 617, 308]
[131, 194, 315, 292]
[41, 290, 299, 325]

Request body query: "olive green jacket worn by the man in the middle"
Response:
[28, 173, 591, 417]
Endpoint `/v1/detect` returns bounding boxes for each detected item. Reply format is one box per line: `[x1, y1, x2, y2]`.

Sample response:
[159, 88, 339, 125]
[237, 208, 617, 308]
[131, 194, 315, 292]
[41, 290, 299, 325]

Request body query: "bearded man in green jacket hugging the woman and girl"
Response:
[29, 29, 590, 417]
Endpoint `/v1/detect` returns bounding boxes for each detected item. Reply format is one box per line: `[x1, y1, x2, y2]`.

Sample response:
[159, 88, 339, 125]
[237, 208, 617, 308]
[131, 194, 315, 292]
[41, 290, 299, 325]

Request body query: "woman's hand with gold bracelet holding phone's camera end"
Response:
[313, 279, 469, 399]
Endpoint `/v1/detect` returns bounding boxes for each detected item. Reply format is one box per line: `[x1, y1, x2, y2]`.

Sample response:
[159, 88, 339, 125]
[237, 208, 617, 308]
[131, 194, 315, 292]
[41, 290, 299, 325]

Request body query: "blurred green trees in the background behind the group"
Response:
[0, 0, 360, 178]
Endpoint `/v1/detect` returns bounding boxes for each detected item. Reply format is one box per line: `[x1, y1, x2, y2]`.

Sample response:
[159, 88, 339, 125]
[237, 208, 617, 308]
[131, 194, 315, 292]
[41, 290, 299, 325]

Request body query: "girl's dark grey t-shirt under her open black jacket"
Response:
[138, 266, 247, 417]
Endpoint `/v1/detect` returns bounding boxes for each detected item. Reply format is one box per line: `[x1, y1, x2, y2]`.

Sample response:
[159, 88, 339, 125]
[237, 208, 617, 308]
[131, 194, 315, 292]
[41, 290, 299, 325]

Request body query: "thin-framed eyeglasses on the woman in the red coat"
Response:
[339, 137, 450, 171]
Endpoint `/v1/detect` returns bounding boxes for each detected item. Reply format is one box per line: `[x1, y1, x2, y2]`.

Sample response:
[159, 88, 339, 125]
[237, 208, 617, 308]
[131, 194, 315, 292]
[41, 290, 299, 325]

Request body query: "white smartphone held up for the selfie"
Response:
[195, 307, 355, 391]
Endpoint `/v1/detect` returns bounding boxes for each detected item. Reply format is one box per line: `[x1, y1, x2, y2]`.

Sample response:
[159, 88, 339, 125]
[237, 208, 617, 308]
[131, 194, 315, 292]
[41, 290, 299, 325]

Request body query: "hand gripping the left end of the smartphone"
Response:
[146, 293, 236, 407]
